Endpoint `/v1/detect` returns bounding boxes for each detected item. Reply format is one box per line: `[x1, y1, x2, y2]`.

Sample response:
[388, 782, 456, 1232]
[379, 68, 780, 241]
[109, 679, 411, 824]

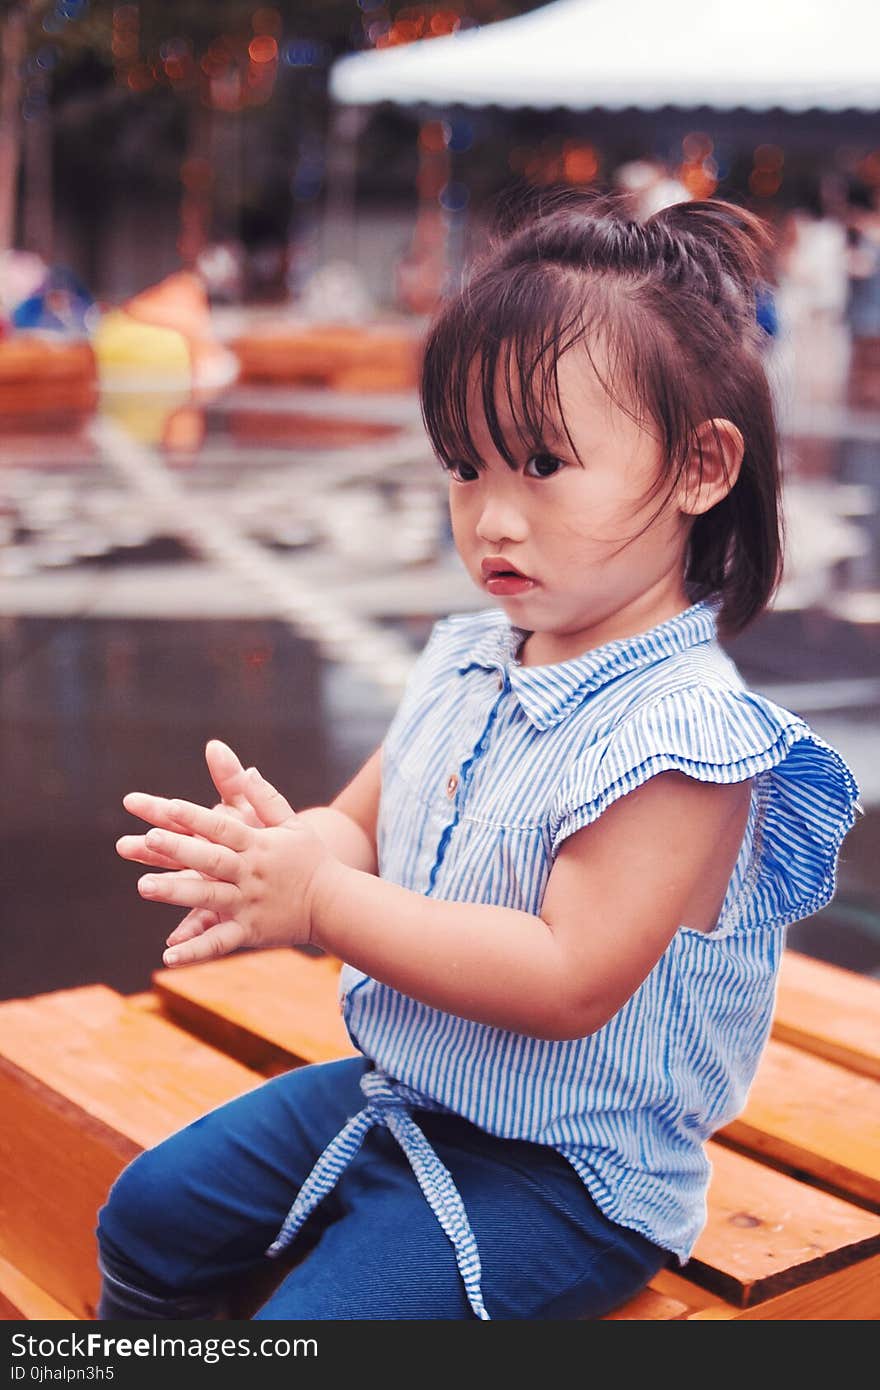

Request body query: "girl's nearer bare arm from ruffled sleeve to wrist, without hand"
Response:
[311, 771, 751, 1038]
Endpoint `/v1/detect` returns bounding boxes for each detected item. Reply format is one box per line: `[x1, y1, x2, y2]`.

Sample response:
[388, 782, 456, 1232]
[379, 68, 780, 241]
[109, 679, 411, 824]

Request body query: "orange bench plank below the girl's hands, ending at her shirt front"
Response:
[153, 948, 356, 1074]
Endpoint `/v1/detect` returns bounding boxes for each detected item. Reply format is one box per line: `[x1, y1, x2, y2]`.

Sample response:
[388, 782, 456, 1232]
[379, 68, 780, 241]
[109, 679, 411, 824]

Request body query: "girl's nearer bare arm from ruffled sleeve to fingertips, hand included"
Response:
[139, 771, 751, 1038]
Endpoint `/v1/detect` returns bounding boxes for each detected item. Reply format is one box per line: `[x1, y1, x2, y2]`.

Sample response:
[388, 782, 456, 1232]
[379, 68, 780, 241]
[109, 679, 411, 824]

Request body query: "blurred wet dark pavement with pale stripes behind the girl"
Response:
[0, 388, 880, 998]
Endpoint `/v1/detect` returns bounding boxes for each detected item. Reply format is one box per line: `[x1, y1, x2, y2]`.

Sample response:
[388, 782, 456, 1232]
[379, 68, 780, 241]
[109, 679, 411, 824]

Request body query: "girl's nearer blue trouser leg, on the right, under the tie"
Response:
[253, 1111, 669, 1321]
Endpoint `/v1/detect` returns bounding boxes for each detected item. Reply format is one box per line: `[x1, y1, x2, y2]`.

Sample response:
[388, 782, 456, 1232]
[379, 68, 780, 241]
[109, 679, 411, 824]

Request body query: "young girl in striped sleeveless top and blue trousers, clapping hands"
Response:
[97, 193, 861, 1319]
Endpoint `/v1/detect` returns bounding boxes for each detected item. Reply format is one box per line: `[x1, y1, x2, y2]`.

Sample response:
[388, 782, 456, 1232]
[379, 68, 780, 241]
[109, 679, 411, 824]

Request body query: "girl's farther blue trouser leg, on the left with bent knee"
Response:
[96, 1058, 366, 1318]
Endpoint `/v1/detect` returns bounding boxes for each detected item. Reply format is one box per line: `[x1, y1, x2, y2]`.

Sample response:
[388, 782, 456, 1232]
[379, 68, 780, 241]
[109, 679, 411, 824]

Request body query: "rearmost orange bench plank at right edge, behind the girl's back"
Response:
[773, 951, 880, 1079]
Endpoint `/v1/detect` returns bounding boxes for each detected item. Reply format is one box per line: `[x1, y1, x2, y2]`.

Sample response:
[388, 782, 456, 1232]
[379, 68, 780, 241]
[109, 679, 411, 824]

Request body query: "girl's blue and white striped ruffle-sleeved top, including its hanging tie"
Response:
[265, 598, 862, 1318]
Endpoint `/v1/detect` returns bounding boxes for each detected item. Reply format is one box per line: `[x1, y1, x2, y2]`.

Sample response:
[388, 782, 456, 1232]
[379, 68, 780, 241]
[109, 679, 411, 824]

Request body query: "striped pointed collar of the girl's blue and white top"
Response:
[459, 595, 722, 730]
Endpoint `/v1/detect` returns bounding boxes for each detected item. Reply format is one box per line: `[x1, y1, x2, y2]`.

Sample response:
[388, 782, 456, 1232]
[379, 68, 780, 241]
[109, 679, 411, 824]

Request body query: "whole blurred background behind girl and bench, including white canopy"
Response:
[0, 0, 880, 998]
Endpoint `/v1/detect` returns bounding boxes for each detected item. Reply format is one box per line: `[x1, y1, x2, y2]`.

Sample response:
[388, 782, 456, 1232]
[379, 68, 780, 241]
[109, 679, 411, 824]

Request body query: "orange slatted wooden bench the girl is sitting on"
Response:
[0, 951, 880, 1321]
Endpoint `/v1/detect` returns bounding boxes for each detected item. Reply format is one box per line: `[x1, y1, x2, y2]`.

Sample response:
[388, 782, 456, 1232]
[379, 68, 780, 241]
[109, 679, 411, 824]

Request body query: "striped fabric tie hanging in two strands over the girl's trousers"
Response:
[266, 1069, 489, 1322]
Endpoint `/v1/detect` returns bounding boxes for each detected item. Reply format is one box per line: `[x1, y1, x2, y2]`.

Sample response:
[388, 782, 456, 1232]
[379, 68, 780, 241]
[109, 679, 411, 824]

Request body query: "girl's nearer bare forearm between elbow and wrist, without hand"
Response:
[311, 865, 580, 1038]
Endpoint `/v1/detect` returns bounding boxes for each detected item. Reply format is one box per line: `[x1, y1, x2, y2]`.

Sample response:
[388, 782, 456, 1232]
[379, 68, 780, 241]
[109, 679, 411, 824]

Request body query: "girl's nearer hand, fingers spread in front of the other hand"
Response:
[128, 773, 336, 966]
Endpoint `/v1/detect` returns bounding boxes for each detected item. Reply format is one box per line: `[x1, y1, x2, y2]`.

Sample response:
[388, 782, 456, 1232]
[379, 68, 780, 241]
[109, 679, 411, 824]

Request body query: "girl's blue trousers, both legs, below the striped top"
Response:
[96, 1058, 669, 1321]
